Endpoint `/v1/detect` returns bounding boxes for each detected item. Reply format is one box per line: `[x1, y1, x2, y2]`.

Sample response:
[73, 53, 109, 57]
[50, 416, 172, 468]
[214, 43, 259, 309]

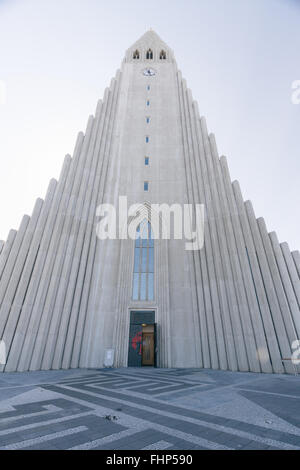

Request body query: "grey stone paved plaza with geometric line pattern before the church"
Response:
[0, 368, 300, 450]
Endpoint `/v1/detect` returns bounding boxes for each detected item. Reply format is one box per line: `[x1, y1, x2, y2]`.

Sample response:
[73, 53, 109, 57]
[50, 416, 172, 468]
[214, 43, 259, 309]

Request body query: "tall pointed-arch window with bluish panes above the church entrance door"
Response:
[132, 219, 154, 301]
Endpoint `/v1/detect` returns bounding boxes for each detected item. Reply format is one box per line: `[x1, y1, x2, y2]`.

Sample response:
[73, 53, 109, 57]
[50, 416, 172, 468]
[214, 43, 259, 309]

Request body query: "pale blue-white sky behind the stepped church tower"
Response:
[0, 0, 300, 249]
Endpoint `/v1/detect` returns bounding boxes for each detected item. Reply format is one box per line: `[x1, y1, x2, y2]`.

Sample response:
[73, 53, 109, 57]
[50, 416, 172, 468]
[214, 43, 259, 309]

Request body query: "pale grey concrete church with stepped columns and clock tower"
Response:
[0, 31, 300, 373]
